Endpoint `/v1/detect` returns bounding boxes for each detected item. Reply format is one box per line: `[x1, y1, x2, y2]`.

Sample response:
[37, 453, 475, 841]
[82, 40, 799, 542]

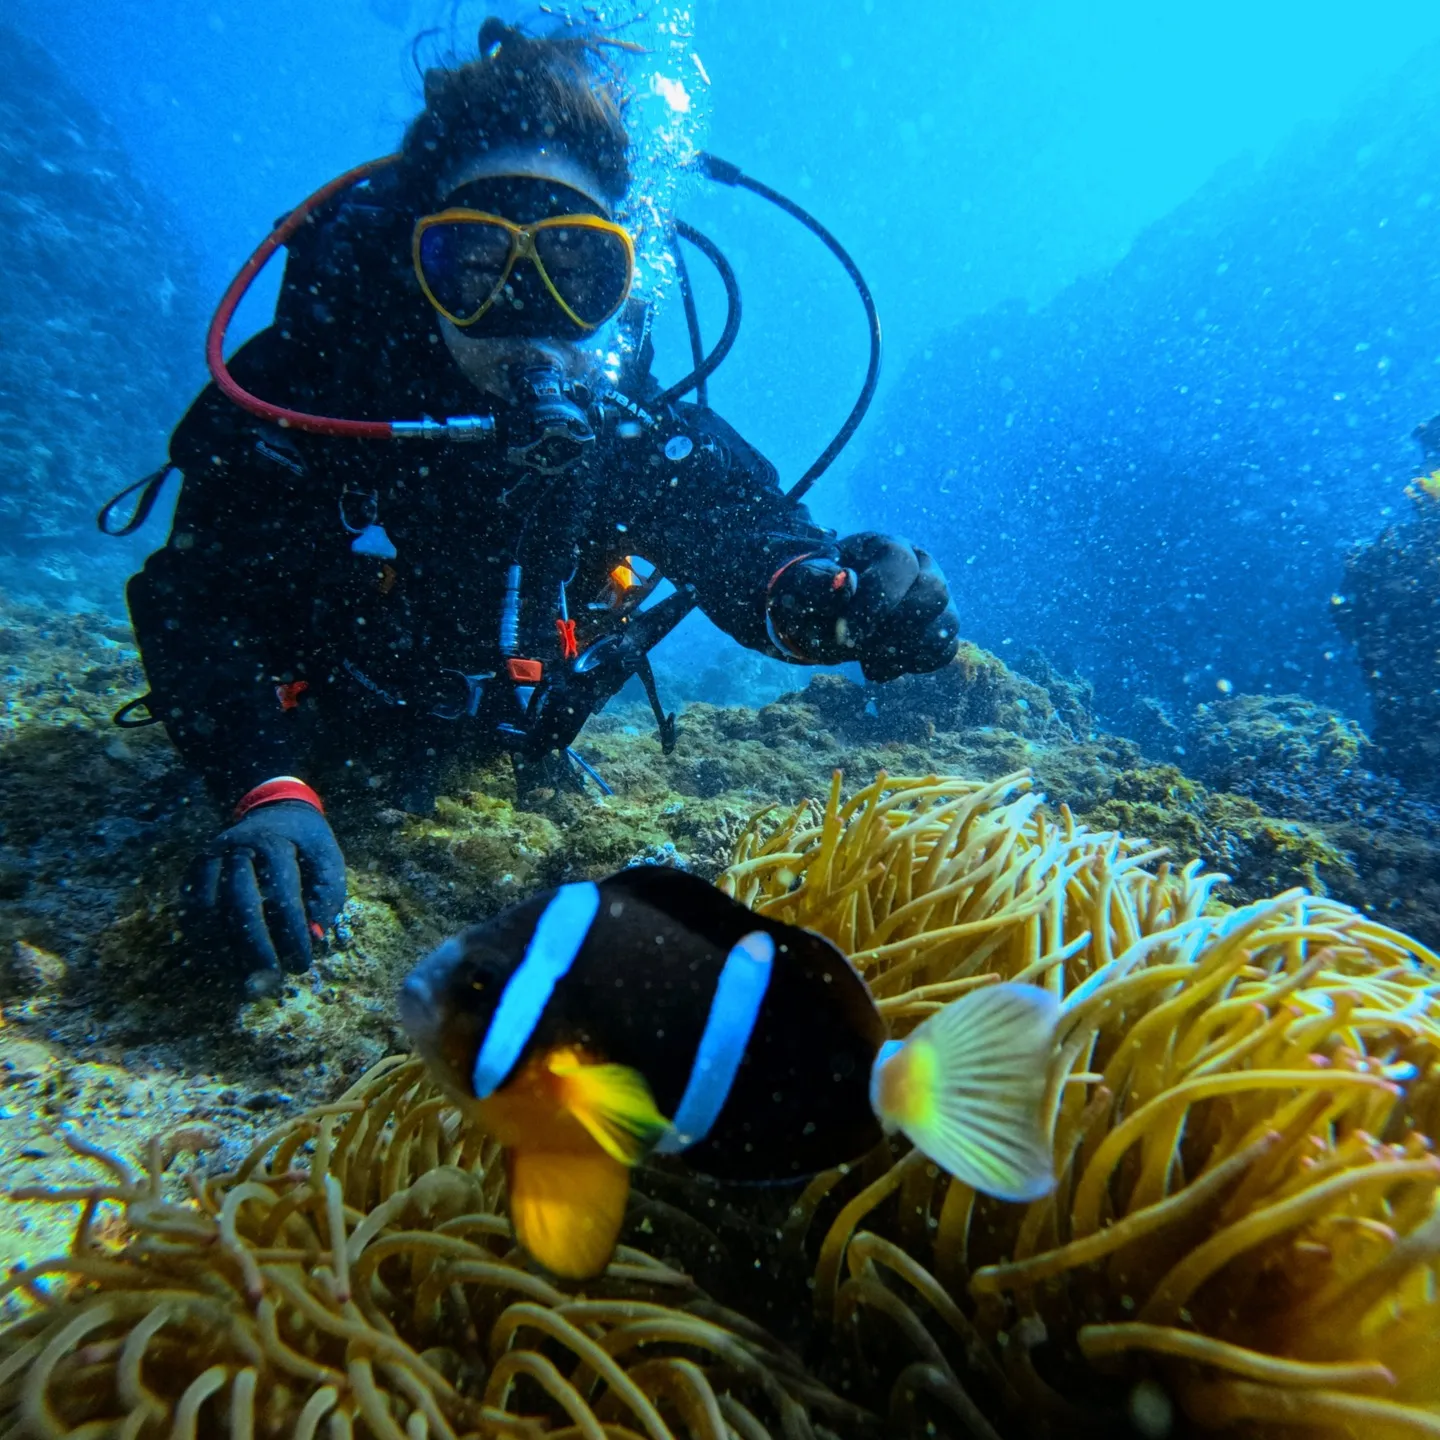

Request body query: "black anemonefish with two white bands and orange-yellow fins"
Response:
[400, 865, 1058, 1280]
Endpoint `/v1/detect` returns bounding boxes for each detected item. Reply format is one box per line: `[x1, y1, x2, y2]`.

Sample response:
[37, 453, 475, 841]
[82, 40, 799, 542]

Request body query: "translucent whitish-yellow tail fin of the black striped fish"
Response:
[870, 984, 1060, 1200]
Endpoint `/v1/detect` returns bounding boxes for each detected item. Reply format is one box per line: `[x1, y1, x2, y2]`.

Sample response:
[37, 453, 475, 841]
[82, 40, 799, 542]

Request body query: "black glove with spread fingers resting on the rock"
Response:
[180, 801, 346, 994]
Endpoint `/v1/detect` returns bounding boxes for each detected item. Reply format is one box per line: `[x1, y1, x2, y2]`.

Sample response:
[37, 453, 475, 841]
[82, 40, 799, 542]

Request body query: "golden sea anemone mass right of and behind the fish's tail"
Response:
[724, 775, 1440, 1436]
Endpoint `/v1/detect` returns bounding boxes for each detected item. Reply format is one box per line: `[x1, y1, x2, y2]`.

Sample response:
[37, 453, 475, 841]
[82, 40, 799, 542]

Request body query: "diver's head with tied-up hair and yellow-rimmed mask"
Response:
[402, 19, 634, 400]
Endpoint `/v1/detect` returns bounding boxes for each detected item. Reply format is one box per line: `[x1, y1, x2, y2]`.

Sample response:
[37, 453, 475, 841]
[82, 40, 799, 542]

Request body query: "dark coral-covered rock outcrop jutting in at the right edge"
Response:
[1332, 481, 1440, 791]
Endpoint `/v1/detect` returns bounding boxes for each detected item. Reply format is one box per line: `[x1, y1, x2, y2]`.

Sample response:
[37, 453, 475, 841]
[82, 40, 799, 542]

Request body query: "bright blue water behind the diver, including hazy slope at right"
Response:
[10, 0, 1440, 717]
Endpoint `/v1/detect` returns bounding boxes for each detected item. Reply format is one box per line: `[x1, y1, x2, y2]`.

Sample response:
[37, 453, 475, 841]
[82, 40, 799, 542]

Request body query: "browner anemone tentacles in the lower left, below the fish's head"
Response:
[0, 1057, 868, 1440]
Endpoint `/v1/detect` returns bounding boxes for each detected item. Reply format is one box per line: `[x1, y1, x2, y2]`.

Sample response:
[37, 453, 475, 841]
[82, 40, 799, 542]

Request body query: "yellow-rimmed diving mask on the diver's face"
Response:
[410, 207, 635, 334]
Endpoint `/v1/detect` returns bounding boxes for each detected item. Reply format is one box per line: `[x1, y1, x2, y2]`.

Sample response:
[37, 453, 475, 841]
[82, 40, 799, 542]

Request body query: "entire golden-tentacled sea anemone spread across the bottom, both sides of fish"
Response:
[0, 775, 1440, 1440]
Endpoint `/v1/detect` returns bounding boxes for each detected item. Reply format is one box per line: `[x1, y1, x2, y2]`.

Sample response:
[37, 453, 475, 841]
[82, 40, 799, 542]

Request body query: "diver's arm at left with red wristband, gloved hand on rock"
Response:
[127, 412, 346, 994]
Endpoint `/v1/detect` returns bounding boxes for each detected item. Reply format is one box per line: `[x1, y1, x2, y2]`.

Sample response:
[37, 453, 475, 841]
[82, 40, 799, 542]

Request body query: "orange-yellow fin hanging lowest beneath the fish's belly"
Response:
[505, 1151, 629, 1280]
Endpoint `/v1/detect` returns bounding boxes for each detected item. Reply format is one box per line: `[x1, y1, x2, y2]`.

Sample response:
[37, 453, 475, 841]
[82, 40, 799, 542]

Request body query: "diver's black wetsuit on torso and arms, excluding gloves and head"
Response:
[128, 181, 835, 805]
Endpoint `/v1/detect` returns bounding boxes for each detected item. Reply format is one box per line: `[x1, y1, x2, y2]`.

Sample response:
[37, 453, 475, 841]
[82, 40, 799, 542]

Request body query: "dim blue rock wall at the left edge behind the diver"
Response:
[0, 24, 202, 603]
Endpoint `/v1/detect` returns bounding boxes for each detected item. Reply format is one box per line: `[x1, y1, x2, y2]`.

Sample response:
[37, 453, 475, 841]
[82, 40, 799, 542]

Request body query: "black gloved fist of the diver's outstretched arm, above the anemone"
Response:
[768, 530, 960, 681]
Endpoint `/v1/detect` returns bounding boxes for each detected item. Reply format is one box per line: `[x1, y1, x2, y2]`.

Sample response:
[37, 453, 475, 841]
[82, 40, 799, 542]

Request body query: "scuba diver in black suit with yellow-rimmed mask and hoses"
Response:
[118, 19, 959, 994]
